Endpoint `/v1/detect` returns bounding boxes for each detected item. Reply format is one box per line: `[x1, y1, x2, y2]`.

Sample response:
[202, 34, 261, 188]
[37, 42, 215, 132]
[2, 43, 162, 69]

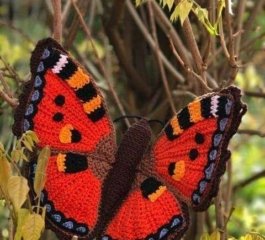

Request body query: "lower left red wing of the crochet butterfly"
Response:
[29, 153, 102, 239]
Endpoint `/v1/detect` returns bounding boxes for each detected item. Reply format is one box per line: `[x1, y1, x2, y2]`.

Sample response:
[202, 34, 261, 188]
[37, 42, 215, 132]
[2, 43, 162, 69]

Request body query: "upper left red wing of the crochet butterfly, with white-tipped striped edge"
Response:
[13, 39, 114, 152]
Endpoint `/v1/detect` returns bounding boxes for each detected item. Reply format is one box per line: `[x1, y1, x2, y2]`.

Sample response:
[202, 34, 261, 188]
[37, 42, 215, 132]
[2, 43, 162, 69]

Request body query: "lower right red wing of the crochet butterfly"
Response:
[102, 174, 188, 240]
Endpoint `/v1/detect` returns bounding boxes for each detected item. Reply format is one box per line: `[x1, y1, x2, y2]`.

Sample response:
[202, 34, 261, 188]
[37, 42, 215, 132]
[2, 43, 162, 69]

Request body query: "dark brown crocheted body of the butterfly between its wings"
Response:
[91, 119, 151, 239]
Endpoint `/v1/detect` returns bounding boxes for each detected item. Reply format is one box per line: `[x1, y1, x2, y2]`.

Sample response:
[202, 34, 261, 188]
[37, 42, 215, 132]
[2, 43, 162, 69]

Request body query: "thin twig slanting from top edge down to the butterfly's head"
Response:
[71, 0, 130, 127]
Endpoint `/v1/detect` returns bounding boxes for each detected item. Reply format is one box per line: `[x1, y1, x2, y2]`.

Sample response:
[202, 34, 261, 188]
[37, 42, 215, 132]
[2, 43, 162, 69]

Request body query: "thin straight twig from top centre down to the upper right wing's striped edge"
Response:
[147, 0, 176, 115]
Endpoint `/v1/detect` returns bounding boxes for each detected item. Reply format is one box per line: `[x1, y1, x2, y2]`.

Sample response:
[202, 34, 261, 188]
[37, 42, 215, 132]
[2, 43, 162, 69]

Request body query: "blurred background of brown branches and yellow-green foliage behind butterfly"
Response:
[0, 0, 265, 240]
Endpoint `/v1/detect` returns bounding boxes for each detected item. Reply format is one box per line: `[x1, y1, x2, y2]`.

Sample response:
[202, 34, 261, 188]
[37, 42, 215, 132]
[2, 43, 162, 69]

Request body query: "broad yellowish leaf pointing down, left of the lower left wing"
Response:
[7, 176, 29, 212]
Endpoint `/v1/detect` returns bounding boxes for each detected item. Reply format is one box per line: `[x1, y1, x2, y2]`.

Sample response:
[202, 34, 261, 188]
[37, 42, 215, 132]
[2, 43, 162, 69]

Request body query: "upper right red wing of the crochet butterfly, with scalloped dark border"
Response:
[153, 87, 246, 210]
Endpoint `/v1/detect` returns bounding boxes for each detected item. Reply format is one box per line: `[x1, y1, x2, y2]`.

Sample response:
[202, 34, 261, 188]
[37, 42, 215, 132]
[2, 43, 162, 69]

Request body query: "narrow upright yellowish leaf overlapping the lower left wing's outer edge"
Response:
[34, 147, 51, 197]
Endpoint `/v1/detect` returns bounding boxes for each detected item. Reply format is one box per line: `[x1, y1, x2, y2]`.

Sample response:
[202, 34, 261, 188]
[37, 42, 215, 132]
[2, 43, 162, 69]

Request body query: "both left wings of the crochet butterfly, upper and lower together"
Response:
[13, 38, 116, 240]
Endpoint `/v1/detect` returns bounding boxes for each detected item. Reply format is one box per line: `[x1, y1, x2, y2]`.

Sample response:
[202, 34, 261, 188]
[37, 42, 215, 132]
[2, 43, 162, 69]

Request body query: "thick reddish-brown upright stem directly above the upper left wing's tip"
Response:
[52, 0, 62, 43]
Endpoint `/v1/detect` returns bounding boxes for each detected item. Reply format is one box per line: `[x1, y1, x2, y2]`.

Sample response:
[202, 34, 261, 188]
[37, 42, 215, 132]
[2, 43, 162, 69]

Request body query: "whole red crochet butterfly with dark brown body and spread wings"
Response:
[13, 39, 246, 240]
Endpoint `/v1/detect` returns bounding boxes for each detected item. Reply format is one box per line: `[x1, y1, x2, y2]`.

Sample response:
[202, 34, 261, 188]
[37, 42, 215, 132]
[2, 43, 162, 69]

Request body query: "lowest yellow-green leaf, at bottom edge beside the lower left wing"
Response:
[22, 213, 45, 240]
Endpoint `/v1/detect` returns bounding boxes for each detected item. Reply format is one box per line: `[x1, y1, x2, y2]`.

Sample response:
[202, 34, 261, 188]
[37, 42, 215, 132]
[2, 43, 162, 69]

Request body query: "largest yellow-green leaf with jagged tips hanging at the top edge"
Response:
[170, 0, 193, 25]
